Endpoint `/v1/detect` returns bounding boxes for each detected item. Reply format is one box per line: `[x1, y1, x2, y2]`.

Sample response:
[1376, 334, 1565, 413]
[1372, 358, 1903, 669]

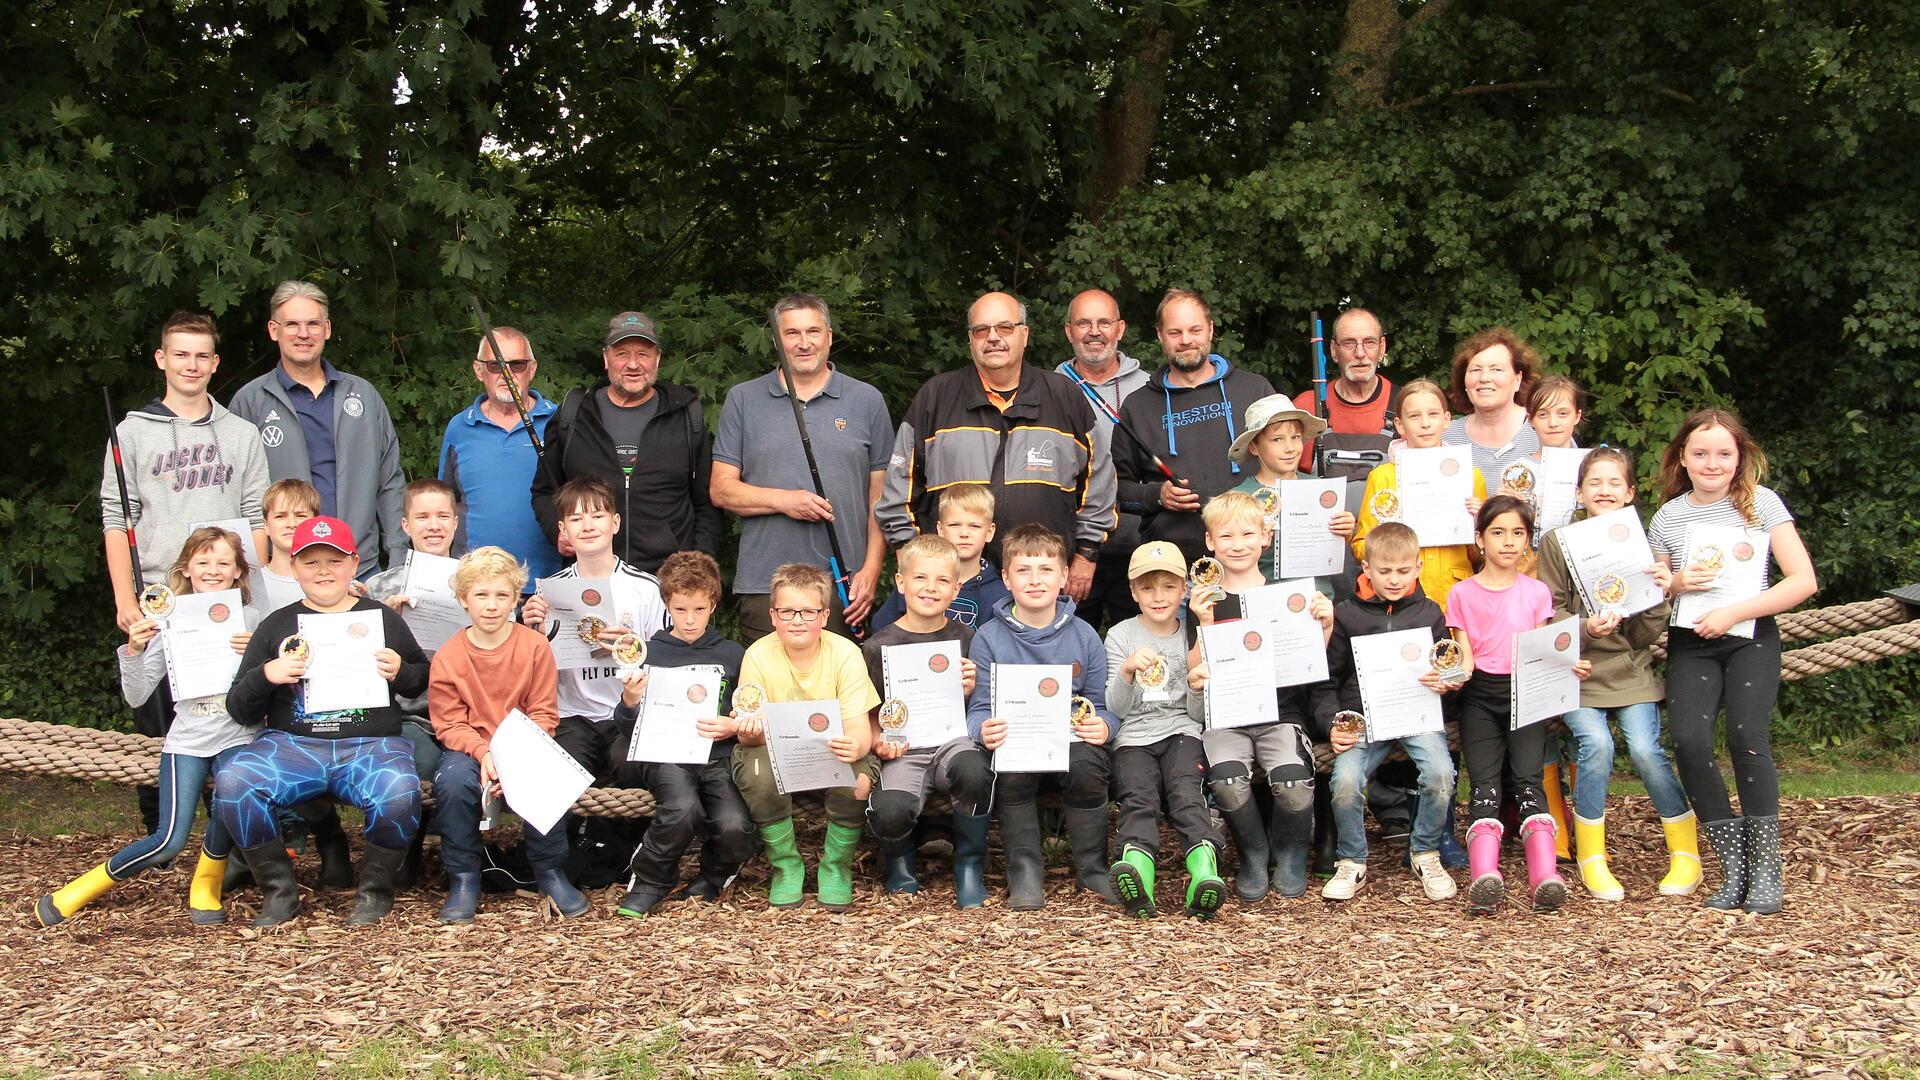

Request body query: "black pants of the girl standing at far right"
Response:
[1667, 619, 1780, 821]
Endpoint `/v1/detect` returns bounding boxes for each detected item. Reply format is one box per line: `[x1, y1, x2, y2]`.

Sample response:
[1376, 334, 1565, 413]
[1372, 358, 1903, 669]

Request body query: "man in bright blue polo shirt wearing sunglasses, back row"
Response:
[440, 327, 561, 592]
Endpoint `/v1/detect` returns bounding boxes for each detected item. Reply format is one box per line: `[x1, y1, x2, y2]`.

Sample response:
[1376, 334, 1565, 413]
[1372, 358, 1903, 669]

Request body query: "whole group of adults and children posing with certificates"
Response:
[36, 281, 1816, 926]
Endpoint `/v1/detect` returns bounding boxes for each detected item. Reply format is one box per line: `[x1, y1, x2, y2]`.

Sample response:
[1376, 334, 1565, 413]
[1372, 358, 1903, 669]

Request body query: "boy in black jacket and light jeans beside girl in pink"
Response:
[1313, 521, 1457, 899]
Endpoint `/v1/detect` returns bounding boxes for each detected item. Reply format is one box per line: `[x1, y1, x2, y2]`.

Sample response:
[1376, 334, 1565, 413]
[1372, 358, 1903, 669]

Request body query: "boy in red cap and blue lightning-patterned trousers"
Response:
[213, 517, 428, 926]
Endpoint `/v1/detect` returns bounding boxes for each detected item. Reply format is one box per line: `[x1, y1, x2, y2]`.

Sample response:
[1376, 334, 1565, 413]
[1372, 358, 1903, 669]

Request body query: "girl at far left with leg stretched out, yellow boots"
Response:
[35, 527, 259, 926]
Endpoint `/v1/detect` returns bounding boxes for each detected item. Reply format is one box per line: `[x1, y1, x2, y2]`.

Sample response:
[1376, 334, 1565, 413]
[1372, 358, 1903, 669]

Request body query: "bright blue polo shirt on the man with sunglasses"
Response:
[440, 390, 561, 594]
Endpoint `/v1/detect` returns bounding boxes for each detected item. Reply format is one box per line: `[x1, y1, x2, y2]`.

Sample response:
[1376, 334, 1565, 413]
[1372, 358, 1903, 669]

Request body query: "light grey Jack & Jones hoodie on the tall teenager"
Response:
[100, 398, 267, 582]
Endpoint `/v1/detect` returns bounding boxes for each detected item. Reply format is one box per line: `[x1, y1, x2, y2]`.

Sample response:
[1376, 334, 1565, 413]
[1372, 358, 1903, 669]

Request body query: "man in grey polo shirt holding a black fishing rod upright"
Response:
[712, 292, 893, 646]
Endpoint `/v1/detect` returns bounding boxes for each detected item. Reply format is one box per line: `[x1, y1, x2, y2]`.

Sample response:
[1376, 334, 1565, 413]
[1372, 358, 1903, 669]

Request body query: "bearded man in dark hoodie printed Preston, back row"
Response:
[1114, 288, 1273, 563]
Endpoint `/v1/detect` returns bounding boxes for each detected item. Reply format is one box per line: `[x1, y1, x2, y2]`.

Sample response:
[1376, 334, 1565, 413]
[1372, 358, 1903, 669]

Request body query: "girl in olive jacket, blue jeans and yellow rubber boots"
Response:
[1540, 445, 1701, 899]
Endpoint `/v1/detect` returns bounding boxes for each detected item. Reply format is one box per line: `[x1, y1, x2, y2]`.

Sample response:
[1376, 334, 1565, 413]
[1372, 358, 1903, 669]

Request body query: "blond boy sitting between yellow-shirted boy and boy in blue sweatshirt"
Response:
[860, 534, 993, 907]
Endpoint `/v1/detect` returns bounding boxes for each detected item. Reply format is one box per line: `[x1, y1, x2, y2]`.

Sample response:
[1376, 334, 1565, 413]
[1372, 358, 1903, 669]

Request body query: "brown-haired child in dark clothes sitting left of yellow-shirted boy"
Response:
[614, 552, 753, 919]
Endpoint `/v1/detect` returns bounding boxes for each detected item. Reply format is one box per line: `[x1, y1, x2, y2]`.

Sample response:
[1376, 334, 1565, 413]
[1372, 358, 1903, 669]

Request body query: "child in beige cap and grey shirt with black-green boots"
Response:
[1106, 540, 1227, 919]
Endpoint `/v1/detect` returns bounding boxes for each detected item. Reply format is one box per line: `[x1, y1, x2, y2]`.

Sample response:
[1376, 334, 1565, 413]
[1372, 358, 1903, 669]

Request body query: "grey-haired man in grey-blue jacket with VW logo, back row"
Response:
[232, 281, 407, 578]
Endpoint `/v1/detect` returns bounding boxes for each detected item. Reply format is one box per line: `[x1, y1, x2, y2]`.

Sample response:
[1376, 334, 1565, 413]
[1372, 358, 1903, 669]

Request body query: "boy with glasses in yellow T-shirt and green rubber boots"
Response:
[733, 563, 879, 911]
